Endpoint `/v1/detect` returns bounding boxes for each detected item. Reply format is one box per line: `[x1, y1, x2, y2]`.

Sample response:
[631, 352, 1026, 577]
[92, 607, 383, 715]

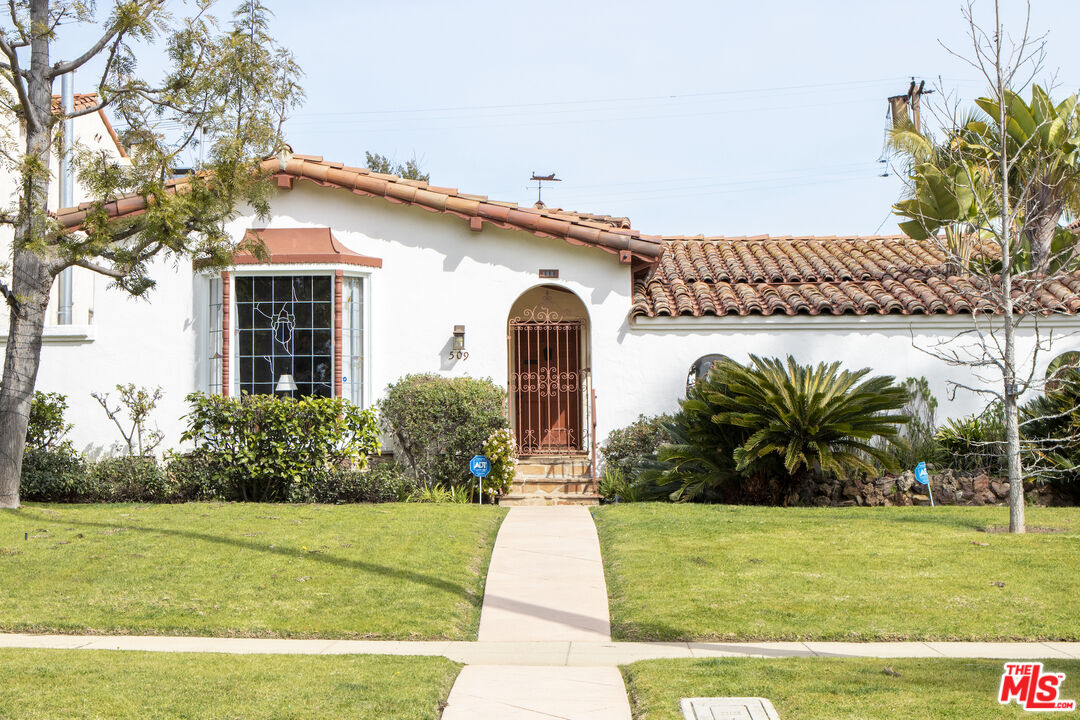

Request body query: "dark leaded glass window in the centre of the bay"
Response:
[235, 275, 334, 397]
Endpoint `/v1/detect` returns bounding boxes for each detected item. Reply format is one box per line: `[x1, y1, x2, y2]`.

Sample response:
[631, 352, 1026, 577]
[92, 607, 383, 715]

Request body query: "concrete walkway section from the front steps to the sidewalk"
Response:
[478, 505, 611, 642]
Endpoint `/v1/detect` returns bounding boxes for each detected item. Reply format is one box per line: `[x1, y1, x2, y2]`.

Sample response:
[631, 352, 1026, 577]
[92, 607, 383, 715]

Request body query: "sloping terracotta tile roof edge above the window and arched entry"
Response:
[262, 154, 662, 262]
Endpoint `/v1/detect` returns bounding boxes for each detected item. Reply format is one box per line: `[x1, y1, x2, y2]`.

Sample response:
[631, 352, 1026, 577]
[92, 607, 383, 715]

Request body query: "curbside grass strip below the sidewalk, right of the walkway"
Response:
[623, 657, 1080, 720]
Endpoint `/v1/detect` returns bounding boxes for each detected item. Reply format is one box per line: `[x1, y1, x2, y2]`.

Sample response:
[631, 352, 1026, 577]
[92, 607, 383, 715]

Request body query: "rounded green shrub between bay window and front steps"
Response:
[379, 375, 510, 488]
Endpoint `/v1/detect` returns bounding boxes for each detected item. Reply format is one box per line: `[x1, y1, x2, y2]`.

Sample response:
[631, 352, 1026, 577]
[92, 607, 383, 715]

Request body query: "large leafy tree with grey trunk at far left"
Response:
[0, 0, 301, 507]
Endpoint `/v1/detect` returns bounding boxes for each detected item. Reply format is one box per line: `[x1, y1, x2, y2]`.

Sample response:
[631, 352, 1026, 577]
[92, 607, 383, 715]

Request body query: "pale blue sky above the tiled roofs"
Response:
[61, 0, 1080, 235]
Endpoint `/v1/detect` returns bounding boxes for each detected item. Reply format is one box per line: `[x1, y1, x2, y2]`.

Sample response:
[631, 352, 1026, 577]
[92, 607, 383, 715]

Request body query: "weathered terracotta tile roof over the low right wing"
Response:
[631, 235, 1080, 317]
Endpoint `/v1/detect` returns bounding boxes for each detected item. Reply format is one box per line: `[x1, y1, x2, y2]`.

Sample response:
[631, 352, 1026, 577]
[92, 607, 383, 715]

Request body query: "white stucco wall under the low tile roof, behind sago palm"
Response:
[622, 315, 1080, 422]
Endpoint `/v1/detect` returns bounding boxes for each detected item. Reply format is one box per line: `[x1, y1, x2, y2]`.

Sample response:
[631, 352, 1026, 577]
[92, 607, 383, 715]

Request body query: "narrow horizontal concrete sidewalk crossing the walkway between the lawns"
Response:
[0, 634, 1080, 667]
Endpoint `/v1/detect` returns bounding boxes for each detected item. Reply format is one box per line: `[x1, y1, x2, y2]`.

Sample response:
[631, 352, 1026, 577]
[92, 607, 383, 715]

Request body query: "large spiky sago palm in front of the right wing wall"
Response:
[639, 355, 907, 503]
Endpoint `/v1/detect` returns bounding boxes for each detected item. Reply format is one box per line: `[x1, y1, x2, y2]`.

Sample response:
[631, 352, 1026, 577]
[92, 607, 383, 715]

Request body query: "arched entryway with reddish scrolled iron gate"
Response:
[508, 285, 590, 456]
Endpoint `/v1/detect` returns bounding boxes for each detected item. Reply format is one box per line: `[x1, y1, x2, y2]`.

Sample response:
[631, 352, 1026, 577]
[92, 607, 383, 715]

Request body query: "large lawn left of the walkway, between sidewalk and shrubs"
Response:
[0, 503, 504, 639]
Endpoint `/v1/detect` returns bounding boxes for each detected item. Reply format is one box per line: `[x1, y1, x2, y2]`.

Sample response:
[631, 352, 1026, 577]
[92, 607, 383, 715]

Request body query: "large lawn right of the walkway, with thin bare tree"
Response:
[594, 503, 1080, 640]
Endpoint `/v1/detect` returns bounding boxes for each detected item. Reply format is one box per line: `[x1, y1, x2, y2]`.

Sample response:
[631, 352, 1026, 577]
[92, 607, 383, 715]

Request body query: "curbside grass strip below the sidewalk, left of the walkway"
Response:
[0, 650, 460, 720]
